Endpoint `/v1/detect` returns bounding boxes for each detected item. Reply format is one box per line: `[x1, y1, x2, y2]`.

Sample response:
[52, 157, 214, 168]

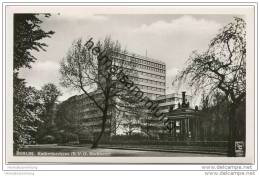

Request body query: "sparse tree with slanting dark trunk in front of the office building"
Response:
[60, 37, 138, 148]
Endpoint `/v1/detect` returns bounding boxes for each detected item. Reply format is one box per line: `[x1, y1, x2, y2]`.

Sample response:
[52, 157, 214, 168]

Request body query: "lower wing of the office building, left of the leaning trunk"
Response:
[56, 91, 115, 141]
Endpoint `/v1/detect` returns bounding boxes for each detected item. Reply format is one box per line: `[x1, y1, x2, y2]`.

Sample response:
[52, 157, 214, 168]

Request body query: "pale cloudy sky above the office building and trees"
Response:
[20, 9, 237, 104]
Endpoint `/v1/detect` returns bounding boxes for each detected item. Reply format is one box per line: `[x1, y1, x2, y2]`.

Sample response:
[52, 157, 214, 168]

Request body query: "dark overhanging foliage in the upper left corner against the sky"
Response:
[14, 14, 54, 70]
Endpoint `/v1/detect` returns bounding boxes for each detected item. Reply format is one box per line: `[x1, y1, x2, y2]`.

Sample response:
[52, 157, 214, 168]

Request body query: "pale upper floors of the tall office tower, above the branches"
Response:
[113, 53, 166, 100]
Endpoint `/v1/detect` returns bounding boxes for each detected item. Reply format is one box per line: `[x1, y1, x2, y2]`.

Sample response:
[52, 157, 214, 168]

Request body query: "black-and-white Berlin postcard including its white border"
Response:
[1, 1, 256, 172]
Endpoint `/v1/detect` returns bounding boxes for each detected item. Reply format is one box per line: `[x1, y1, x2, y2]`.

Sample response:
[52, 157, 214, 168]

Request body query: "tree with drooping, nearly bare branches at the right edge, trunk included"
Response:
[175, 18, 246, 156]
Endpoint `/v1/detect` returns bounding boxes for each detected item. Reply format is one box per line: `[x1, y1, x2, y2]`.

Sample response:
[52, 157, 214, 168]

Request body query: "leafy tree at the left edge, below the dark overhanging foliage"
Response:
[13, 73, 43, 152]
